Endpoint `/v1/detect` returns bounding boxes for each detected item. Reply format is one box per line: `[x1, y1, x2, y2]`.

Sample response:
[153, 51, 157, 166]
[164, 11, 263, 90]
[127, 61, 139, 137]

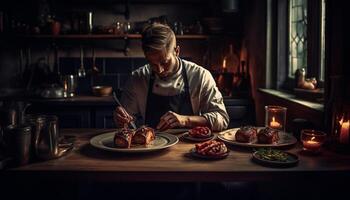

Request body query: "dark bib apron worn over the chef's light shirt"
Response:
[145, 59, 193, 128]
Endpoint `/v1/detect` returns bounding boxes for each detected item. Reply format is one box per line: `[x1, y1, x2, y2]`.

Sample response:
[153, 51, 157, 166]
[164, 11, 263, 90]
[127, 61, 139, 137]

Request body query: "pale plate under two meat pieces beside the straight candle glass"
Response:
[218, 127, 297, 147]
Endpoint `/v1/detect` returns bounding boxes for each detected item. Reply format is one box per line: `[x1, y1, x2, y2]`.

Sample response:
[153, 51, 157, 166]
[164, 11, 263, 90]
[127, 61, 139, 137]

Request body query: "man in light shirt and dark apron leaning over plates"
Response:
[114, 23, 229, 131]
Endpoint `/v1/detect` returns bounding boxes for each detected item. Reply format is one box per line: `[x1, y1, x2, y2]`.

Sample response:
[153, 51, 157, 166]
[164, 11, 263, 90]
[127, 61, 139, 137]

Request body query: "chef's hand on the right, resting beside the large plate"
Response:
[156, 111, 189, 131]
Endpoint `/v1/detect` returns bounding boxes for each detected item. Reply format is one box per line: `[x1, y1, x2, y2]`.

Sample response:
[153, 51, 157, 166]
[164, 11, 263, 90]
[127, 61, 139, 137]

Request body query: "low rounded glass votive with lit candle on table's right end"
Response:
[300, 129, 327, 153]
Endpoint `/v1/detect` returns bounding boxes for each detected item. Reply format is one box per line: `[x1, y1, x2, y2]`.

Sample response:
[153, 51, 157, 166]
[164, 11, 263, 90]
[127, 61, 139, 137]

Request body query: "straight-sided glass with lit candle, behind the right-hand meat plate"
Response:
[265, 106, 287, 131]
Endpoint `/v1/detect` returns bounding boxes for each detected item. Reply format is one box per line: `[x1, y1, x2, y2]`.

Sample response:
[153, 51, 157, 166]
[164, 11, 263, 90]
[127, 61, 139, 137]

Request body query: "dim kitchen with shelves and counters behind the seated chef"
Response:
[0, 0, 350, 131]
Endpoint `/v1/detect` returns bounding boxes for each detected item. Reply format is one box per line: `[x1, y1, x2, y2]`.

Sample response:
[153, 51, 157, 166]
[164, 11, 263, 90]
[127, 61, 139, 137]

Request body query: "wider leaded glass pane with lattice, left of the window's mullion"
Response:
[288, 0, 307, 78]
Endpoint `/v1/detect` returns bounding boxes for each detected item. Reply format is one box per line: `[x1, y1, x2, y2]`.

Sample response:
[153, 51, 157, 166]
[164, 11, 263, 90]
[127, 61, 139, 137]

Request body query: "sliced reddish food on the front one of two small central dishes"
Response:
[196, 140, 227, 157]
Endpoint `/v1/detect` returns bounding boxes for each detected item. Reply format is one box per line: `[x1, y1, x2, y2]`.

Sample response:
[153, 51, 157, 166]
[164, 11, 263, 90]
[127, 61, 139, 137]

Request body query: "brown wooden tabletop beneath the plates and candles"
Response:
[0, 129, 350, 182]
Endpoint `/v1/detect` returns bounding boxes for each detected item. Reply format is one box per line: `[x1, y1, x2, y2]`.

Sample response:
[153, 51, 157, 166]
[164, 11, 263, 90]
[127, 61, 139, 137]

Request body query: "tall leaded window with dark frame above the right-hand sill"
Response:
[267, 0, 326, 90]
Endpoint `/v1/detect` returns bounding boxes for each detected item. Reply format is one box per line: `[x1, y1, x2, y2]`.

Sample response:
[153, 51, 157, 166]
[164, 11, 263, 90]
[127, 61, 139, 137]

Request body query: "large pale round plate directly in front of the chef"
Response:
[90, 132, 179, 153]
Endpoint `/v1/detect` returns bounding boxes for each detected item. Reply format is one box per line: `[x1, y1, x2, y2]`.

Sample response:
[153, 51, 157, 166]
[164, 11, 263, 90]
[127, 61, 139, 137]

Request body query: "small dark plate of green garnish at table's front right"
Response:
[252, 148, 299, 167]
